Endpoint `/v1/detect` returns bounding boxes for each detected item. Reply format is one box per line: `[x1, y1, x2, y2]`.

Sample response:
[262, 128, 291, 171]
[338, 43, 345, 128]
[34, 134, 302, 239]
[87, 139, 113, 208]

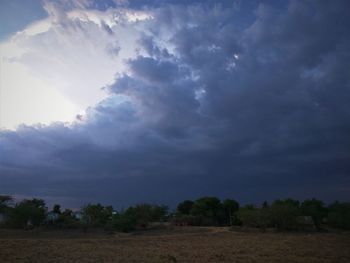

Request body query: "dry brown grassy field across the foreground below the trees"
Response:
[0, 227, 350, 263]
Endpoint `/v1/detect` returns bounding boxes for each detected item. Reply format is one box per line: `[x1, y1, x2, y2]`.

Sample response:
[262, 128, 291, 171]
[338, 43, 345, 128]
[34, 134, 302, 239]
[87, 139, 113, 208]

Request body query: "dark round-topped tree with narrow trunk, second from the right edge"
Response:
[300, 198, 327, 228]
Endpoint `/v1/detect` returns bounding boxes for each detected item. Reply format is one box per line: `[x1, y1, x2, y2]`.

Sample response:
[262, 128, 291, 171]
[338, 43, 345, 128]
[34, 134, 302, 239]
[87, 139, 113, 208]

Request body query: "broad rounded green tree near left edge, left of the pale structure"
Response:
[9, 198, 47, 228]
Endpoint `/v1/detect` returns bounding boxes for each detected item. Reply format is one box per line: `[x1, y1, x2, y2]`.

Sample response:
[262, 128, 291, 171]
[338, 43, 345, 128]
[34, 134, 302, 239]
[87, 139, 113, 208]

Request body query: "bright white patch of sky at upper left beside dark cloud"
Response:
[0, 1, 152, 129]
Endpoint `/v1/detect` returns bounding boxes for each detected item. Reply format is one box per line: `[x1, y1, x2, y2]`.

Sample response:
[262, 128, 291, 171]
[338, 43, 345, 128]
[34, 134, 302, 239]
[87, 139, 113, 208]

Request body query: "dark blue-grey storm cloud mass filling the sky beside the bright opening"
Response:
[0, 1, 350, 208]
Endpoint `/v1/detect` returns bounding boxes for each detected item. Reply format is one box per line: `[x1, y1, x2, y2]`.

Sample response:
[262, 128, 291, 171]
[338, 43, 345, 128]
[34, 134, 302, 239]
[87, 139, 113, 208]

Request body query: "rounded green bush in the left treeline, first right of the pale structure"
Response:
[82, 204, 113, 227]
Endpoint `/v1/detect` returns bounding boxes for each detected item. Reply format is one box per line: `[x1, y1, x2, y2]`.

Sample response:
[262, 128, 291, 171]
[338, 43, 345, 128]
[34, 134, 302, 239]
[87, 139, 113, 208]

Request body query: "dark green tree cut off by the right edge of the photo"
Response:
[327, 202, 350, 230]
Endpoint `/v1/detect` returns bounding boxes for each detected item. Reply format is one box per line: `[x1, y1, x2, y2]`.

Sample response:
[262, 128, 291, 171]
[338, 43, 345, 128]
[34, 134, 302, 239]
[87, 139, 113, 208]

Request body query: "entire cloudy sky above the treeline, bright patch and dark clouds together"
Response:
[0, 0, 350, 208]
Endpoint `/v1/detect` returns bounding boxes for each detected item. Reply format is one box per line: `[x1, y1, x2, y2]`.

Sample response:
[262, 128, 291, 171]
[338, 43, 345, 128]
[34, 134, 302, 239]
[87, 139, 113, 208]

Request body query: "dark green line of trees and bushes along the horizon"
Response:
[0, 195, 350, 232]
